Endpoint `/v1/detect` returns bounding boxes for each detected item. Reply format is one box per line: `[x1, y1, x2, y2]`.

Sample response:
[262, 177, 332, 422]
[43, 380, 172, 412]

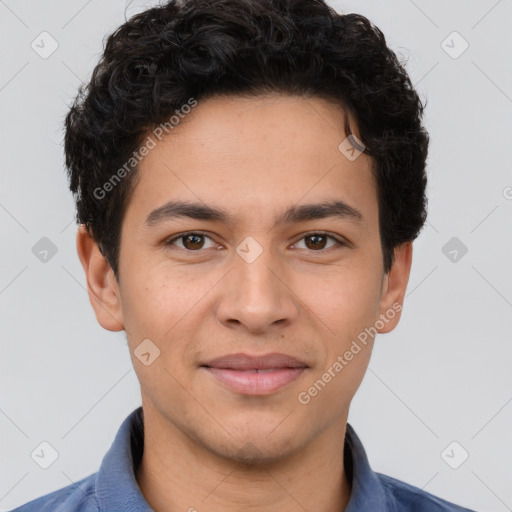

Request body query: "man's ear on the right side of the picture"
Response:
[378, 242, 412, 333]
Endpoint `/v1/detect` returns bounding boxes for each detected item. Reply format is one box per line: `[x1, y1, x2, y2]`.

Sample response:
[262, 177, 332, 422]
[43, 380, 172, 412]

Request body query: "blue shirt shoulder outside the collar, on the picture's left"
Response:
[11, 473, 99, 512]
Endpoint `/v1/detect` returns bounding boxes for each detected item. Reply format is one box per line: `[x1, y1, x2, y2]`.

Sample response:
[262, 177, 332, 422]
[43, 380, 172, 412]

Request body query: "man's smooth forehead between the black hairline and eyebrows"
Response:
[127, 95, 377, 230]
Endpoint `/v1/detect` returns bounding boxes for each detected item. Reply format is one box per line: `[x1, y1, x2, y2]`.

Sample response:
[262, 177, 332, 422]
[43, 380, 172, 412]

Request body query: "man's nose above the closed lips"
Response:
[217, 242, 299, 334]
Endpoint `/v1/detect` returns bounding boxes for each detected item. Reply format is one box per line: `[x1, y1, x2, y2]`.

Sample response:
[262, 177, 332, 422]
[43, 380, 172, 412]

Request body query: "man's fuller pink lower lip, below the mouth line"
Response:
[204, 367, 306, 395]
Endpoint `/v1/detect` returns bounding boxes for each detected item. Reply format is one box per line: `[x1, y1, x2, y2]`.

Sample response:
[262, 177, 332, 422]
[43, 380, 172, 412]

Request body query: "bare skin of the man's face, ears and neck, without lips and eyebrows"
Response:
[77, 95, 412, 512]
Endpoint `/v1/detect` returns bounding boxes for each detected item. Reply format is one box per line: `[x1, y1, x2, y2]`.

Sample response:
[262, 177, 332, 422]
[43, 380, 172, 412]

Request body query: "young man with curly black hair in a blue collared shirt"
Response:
[11, 0, 476, 512]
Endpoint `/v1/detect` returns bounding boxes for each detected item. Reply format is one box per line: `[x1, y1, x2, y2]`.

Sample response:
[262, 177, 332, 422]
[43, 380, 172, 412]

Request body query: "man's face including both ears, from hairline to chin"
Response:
[79, 95, 411, 461]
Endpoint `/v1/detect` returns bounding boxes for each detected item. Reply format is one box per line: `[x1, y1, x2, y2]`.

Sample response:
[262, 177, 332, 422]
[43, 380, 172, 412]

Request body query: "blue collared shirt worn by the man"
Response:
[11, 407, 474, 512]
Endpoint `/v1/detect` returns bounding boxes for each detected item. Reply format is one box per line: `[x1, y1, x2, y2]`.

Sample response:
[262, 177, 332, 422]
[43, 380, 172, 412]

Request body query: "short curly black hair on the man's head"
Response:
[64, 0, 429, 279]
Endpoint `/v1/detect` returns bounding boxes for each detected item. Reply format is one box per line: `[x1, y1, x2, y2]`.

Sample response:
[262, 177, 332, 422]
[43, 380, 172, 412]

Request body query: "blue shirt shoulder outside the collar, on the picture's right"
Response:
[376, 473, 475, 512]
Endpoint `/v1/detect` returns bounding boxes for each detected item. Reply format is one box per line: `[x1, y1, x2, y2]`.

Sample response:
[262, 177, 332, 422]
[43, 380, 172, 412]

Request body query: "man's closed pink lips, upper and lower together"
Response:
[201, 353, 309, 395]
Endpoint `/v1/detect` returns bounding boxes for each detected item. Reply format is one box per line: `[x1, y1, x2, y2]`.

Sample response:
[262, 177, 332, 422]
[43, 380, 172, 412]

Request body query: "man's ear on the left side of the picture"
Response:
[76, 224, 124, 331]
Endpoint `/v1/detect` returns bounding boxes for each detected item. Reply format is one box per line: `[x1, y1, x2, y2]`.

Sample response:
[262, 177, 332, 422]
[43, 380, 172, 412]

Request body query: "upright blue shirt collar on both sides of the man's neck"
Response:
[95, 407, 391, 512]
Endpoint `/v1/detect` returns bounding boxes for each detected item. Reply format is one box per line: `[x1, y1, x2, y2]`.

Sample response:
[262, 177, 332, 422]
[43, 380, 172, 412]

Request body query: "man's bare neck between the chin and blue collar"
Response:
[136, 407, 350, 512]
